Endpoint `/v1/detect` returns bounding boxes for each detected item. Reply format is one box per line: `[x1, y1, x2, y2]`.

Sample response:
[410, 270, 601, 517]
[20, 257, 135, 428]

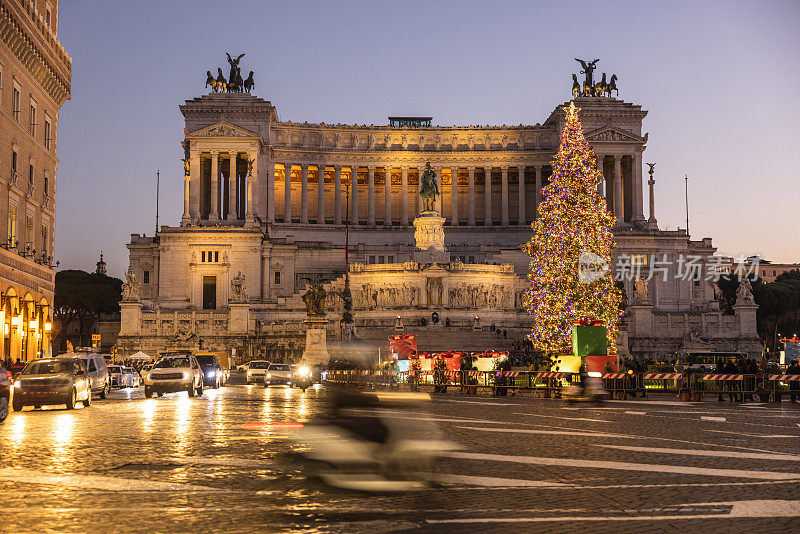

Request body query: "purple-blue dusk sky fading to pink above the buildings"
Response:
[56, 0, 800, 277]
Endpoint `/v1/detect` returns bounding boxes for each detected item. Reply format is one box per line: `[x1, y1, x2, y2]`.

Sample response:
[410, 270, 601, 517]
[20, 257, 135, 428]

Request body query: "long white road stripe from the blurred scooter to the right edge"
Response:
[439, 451, 800, 480]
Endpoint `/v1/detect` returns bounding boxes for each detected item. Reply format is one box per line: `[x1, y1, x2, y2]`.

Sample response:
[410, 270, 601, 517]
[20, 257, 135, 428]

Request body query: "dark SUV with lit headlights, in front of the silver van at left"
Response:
[11, 358, 92, 412]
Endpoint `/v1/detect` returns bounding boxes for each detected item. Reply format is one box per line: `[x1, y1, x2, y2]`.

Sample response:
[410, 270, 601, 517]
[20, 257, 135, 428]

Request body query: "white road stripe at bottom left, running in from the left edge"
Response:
[0, 467, 230, 492]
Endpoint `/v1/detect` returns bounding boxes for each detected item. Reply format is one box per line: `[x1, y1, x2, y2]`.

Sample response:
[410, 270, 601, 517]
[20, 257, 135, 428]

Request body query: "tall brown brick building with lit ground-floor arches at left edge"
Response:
[0, 0, 72, 361]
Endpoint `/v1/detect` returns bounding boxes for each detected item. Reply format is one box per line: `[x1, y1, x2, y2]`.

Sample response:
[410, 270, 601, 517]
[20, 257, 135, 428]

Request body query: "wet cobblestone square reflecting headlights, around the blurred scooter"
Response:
[0, 386, 800, 533]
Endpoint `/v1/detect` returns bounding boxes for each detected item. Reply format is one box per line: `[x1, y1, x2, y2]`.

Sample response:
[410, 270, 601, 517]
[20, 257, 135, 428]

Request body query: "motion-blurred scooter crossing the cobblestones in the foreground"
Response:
[288, 389, 456, 492]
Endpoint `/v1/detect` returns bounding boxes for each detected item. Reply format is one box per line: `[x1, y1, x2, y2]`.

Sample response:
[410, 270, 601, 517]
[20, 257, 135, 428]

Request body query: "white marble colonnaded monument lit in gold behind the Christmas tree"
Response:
[120, 62, 760, 364]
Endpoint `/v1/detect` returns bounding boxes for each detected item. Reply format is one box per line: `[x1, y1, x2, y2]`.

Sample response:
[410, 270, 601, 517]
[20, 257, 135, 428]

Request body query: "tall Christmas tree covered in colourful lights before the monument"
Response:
[524, 103, 622, 355]
